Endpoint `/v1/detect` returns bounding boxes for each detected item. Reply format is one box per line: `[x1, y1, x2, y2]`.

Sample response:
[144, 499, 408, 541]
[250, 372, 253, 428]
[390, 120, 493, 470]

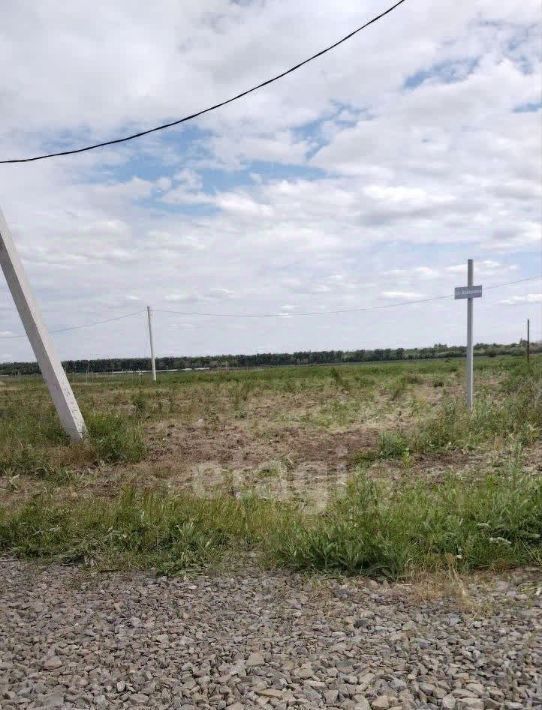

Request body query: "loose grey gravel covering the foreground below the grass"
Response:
[0, 560, 542, 710]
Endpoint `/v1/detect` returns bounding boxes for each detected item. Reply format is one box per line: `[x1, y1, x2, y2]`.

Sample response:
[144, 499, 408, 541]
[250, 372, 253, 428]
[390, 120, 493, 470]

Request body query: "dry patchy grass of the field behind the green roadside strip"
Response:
[0, 358, 537, 504]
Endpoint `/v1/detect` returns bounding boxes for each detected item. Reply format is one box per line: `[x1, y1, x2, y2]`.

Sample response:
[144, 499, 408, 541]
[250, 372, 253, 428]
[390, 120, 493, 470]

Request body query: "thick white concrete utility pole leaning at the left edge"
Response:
[0, 204, 86, 441]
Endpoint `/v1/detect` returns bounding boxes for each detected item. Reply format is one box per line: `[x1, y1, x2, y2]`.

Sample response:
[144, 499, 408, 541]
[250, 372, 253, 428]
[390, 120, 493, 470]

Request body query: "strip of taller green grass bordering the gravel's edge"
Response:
[0, 465, 542, 578]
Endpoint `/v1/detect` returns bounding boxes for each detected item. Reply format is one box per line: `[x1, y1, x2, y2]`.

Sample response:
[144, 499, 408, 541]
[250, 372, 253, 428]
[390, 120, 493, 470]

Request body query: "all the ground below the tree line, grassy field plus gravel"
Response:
[0, 358, 542, 710]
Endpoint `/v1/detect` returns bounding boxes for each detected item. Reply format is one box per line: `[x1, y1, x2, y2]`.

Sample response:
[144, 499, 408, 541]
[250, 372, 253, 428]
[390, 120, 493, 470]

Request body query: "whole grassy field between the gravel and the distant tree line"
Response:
[0, 357, 542, 578]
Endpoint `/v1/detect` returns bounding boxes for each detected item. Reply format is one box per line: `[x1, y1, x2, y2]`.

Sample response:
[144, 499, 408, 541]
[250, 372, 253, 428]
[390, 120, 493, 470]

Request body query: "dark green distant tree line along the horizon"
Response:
[0, 341, 542, 375]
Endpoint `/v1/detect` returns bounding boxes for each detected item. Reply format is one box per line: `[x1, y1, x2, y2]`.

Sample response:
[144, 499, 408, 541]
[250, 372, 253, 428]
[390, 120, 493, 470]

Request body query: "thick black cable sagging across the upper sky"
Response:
[0, 0, 406, 165]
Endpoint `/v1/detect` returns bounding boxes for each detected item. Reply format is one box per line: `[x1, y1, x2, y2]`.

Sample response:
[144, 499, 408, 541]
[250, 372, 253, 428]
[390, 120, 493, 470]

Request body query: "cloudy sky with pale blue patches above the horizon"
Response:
[0, 0, 542, 361]
